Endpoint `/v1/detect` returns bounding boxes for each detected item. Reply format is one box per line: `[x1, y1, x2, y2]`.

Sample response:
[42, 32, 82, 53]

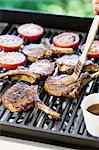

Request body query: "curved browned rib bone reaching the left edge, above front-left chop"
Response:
[0, 69, 39, 83]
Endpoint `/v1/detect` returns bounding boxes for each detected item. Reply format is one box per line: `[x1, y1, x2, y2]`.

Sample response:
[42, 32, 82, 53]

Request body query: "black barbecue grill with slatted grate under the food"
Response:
[0, 9, 99, 148]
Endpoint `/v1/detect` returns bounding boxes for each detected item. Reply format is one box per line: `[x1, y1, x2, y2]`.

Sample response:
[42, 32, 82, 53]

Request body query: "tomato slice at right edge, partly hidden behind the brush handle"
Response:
[81, 40, 99, 58]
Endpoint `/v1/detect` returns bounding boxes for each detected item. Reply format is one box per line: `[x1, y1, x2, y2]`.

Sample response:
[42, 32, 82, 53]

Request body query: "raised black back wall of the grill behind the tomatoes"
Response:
[0, 8, 93, 32]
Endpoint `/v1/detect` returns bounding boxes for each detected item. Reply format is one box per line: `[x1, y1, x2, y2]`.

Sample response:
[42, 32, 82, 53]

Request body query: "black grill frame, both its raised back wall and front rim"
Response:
[0, 9, 99, 148]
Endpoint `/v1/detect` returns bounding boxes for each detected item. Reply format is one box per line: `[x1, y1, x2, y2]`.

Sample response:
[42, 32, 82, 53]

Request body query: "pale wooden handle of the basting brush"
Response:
[79, 15, 99, 64]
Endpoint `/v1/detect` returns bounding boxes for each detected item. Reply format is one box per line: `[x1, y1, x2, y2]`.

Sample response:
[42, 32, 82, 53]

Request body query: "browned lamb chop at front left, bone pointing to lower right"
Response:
[2, 82, 60, 118]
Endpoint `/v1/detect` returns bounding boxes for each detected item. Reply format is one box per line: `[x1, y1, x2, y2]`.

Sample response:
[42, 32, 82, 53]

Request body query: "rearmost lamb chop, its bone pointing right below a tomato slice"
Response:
[22, 39, 74, 62]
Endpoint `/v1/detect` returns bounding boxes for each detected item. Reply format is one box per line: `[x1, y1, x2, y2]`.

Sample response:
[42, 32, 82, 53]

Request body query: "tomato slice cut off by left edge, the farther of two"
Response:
[0, 34, 23, 51]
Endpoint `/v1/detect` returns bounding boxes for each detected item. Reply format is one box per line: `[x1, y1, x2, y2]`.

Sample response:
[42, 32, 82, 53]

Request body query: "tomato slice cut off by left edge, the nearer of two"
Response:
[0, 52, 25, 69]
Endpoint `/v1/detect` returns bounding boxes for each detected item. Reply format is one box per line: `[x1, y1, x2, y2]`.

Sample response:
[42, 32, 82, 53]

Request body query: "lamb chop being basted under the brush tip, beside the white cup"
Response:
[44, 71, 99, 98]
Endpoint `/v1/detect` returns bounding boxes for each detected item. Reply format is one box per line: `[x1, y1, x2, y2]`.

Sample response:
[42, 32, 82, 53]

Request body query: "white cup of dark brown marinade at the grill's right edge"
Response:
[81, 93, 99, 137]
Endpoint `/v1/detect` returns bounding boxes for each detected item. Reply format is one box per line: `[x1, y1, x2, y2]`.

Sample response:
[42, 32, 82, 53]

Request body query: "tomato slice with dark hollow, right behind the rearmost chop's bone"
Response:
[52, 32, 79, 48]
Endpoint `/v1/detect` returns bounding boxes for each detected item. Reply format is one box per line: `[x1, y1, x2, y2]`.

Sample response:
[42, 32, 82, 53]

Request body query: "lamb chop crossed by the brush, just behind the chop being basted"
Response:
[56, 54, 99, 74]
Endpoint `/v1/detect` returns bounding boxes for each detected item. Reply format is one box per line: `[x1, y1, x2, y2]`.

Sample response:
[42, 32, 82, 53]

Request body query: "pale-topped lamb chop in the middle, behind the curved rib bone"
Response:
[12, 59, 55, 83]
